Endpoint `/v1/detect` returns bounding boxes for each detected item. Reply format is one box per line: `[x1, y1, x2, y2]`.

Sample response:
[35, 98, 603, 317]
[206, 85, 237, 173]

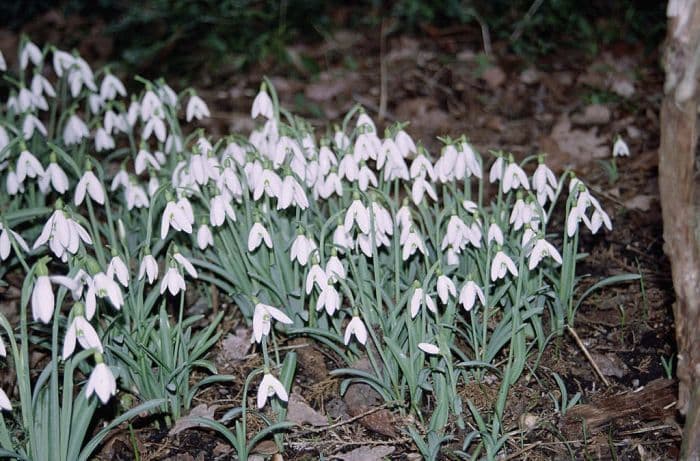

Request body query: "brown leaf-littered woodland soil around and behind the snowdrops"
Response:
[0, 9, 680, 461]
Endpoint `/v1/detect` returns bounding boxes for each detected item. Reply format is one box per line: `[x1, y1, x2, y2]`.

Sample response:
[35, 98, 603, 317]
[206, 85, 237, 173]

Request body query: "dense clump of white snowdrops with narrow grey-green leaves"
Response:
[0, 39, 628, 460]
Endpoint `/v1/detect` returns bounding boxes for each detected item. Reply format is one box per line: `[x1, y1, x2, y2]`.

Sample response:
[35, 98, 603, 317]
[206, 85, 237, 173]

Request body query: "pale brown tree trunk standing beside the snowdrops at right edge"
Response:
[659, 0, 700, 461]
